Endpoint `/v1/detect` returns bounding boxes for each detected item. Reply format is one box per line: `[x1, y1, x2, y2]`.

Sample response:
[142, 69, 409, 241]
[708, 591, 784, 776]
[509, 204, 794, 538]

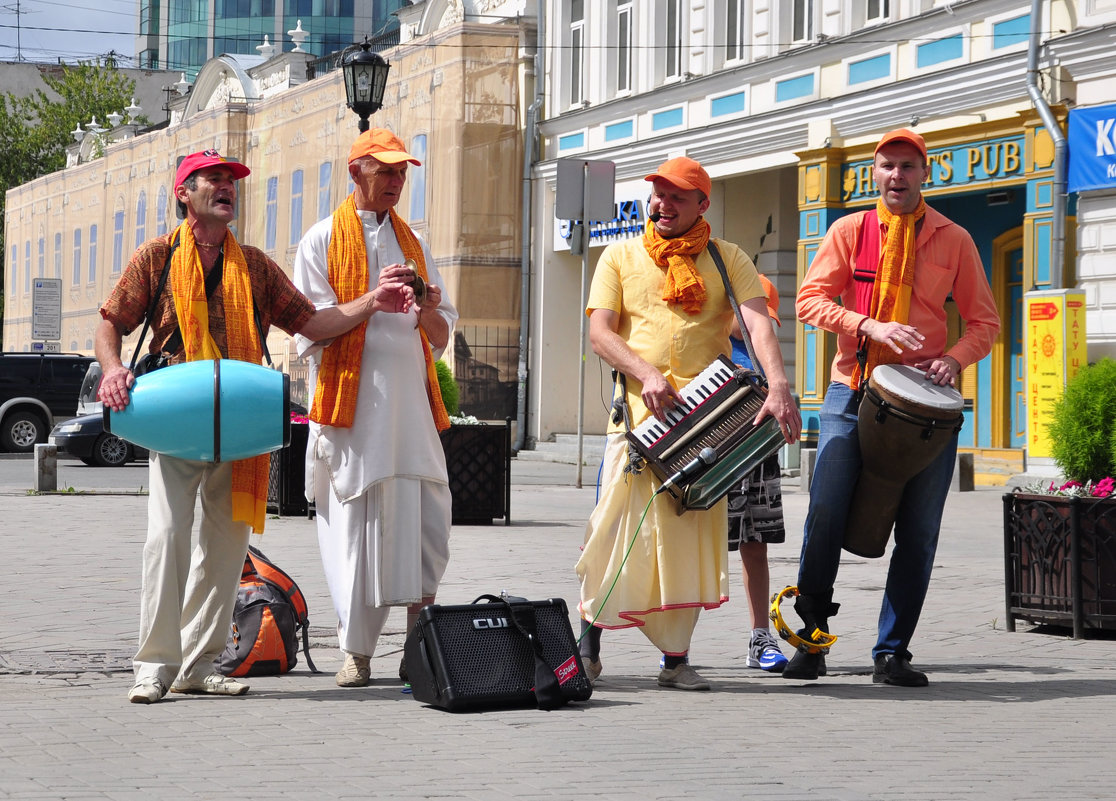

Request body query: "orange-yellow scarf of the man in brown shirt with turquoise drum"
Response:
[171, 222, 271, 533]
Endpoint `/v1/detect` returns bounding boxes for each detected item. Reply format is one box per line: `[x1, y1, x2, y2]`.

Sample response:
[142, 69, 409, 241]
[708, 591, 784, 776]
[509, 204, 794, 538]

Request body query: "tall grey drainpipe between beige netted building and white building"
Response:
[512, 9, 546, 453]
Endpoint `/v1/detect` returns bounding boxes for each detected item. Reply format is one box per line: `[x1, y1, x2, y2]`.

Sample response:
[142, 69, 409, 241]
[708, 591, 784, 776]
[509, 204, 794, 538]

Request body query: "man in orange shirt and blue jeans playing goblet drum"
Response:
[782, 128, 1000, 687]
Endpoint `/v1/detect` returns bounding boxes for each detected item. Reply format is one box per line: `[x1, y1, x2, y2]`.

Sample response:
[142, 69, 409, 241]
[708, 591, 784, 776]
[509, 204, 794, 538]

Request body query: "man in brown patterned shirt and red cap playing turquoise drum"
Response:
[96, 151, 413, 704]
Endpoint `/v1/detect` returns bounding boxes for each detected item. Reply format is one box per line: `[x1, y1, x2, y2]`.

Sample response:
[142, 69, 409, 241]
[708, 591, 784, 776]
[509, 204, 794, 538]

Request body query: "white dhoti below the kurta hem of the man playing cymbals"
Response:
[315, 466, 452, 657]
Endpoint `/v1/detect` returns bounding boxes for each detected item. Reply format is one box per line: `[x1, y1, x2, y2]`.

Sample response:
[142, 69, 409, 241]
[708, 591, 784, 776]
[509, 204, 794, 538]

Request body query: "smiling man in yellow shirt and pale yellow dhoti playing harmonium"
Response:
[577, 156, 801, 689]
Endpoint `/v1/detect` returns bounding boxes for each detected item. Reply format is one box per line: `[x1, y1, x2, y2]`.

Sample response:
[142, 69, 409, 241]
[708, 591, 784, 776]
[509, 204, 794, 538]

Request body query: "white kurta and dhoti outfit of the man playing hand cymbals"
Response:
[295, 212, 458, 656]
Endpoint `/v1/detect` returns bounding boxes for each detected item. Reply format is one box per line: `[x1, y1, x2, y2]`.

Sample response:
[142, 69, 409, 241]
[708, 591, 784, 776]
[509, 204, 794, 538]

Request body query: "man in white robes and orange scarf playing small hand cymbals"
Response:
[295, 128, 458, 687]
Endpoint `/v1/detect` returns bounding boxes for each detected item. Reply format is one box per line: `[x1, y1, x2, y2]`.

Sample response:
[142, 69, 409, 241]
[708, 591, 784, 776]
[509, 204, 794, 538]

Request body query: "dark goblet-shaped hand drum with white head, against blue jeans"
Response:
[844, 365, 964, 559]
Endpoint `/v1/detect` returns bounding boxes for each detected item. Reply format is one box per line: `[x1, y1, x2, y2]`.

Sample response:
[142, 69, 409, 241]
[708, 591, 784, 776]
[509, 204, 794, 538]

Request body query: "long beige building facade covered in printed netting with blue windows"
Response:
[3, 3, 535, 418]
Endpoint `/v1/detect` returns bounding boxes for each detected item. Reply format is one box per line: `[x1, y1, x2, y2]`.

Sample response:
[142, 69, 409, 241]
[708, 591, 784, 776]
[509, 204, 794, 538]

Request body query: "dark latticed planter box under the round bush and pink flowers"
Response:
[1003, 492, 1116, 638]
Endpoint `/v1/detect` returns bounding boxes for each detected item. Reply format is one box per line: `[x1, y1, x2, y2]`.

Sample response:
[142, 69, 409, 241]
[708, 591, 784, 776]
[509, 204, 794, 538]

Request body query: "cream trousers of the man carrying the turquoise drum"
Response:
[132, 453, 251, 686]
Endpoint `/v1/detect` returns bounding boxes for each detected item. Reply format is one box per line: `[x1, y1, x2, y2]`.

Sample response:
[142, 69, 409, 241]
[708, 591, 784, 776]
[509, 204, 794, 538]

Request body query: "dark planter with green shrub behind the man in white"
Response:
[434, 360, 511, 525]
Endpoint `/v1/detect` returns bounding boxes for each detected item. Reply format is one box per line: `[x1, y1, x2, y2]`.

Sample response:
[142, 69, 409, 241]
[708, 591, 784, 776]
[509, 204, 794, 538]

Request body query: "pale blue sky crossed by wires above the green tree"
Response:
[0, 0, 140, 67]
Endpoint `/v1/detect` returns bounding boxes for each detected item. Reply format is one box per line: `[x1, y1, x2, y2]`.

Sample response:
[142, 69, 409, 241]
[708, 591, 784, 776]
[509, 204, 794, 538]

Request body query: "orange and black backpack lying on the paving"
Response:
[214, 546, 318, 676]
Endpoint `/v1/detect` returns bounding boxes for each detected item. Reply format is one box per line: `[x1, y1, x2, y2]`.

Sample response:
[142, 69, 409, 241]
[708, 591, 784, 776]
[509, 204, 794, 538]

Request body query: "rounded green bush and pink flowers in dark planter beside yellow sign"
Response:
[1003, 358, 1116, 637]
